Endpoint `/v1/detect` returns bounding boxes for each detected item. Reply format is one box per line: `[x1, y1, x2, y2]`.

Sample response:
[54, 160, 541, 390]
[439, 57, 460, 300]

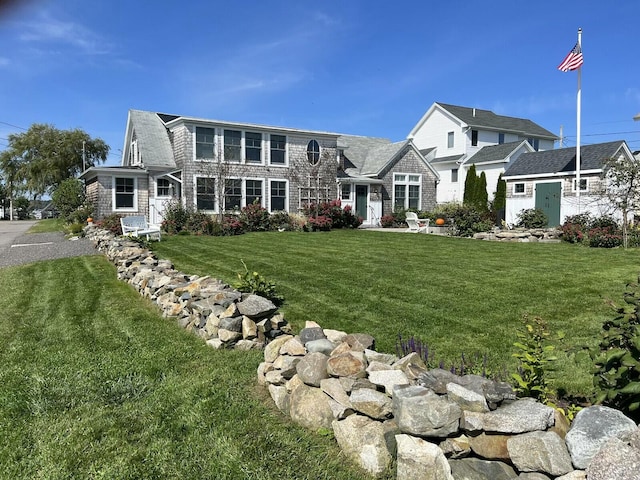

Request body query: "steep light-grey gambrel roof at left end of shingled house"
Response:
[122, 110, 176, 169]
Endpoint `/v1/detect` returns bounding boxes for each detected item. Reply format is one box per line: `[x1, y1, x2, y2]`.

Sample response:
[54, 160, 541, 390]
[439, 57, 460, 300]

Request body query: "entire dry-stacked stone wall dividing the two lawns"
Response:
[85, 227, 640, 480]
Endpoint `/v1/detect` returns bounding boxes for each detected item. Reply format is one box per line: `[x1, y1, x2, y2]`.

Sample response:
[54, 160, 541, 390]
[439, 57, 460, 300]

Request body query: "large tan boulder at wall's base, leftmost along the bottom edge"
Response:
[332, 415, 397, 475]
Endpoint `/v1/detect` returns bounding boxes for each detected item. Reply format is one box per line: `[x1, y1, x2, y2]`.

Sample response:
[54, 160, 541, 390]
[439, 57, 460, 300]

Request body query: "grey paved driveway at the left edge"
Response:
[0, 220, 98, 267]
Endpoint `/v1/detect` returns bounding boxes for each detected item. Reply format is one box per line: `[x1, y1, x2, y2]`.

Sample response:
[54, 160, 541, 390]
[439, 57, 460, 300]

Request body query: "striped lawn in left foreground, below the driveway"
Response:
[0, 256, 376, 480]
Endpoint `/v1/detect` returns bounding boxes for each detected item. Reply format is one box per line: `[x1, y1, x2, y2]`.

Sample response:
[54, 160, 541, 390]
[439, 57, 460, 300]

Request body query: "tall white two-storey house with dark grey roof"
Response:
[408, 102, 557, 203]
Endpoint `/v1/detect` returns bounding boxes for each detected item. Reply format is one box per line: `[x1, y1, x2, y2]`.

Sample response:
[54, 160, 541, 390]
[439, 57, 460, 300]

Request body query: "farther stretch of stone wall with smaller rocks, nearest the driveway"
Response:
[85, 227, 291, 350]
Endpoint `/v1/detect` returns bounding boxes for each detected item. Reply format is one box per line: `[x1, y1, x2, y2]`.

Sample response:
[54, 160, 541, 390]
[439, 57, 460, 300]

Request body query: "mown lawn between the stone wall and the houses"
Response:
[153, 230, 640, 395]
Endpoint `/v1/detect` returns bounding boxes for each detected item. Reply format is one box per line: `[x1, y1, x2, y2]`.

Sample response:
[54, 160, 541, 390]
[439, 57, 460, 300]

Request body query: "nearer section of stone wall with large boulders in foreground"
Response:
[258, 322, 640, 480]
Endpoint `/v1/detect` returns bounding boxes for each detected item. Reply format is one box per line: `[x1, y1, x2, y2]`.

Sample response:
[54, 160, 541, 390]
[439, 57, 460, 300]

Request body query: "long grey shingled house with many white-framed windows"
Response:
[81, 110, 437, 226]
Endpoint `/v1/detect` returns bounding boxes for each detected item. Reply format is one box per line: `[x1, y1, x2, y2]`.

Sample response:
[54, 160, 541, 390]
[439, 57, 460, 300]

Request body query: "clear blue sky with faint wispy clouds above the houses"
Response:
[0, 0, 640, 165]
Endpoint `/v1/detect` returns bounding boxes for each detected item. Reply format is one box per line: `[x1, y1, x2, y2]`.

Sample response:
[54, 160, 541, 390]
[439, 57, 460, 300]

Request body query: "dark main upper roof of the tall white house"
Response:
[437, 102, 557, 139]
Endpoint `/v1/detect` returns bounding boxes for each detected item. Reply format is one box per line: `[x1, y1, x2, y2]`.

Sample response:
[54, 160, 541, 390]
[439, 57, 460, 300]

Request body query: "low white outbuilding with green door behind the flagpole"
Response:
[503, 140, 635, 226]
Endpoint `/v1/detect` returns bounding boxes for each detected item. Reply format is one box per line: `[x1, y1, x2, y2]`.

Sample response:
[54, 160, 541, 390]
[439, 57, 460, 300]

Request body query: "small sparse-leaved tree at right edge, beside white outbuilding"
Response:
[598, 155, 640, 248]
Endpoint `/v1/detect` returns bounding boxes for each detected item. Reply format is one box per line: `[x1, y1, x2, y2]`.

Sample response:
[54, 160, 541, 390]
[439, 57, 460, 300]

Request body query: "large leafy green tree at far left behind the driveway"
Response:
[0, 123, 109, 199]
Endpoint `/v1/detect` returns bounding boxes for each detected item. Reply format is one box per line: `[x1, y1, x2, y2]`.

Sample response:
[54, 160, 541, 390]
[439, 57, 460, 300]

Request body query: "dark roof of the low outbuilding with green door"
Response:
[503, 140, 631, 177]
